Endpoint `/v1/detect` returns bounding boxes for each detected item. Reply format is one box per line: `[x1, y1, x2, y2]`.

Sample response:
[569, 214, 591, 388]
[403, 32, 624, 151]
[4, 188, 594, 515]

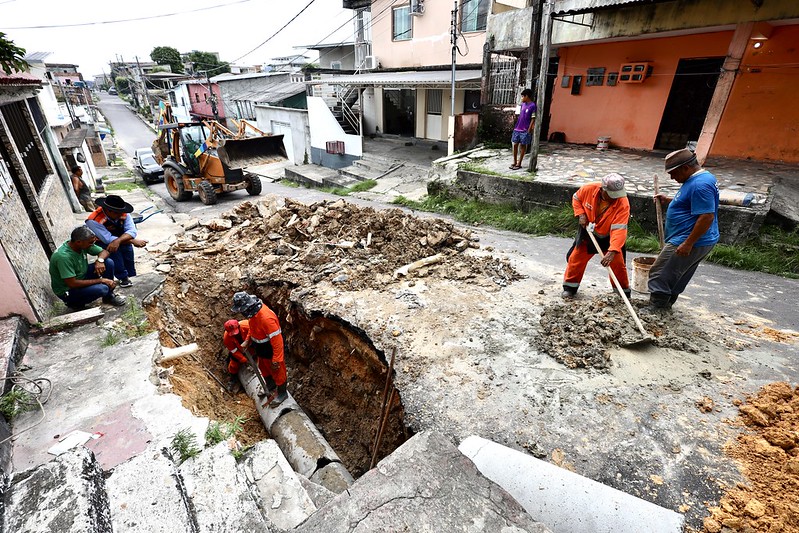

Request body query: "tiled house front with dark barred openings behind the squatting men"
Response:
[0, 73, 80, 322]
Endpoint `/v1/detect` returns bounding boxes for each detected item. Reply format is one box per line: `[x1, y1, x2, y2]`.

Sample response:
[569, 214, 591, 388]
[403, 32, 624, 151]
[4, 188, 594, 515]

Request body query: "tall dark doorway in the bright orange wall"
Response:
[655, 57, 724, 150]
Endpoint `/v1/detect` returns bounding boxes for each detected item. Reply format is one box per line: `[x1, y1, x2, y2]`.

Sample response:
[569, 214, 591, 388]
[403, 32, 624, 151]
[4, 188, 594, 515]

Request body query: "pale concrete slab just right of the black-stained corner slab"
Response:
[106, 449, 193, 533]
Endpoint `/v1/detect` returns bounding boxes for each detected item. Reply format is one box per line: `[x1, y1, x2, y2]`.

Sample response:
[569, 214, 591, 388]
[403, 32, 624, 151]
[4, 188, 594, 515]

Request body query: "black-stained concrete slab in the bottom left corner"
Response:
[2, 447, 112, 533]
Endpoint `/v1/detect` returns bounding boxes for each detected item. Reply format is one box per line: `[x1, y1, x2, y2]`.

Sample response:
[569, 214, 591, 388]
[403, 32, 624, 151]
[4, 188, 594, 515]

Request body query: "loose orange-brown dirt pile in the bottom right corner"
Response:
[704, 382, 799, 533]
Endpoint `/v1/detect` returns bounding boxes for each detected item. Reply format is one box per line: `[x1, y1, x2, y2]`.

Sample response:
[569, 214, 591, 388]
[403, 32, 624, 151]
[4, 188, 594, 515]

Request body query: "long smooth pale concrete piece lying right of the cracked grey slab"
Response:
[459, 436, 684, 533]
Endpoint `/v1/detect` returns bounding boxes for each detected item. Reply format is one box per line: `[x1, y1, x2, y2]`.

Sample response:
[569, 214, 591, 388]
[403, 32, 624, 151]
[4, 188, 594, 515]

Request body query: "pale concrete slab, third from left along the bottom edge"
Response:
[178, 442, 274, 533]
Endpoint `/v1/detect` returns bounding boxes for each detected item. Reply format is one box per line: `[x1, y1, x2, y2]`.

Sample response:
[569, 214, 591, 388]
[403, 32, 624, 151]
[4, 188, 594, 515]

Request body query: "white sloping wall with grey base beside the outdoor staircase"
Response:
[308, 96, 363, 168]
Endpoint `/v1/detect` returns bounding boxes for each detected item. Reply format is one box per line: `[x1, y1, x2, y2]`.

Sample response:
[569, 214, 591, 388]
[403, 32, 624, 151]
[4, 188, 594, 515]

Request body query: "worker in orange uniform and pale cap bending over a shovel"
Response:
[562, 173, 630, 299]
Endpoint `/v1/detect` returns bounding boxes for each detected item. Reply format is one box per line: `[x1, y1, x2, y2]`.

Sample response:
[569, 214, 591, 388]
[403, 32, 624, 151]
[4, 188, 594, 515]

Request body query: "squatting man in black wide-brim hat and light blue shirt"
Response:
[86, 194, 147, 287]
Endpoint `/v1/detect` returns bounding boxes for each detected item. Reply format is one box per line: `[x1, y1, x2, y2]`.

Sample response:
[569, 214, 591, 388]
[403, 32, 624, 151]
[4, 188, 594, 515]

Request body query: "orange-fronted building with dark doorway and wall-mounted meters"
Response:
[487, 0, 799, 162]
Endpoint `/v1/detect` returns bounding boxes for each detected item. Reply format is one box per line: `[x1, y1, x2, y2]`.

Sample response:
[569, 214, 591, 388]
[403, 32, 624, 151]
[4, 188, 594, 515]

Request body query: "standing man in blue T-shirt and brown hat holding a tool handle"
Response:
[649, 149, 719, 311]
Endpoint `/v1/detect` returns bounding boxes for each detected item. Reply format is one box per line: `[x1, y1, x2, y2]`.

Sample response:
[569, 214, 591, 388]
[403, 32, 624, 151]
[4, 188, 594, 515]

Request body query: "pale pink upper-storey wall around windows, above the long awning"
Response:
[372, 0, 486, 68]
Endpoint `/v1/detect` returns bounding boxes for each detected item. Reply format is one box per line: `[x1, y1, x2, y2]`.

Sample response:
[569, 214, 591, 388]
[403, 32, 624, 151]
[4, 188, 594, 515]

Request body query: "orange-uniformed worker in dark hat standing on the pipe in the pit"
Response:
[231, 292, 288, 407]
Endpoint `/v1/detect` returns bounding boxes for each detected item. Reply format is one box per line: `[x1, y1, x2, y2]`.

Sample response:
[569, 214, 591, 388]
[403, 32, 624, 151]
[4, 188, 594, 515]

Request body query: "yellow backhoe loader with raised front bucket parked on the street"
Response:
[153, 102, 287, 205]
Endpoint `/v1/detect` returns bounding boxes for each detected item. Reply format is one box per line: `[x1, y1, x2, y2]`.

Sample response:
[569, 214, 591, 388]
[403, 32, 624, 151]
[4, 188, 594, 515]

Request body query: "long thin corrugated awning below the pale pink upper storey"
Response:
[318, 70, 483, 87]
